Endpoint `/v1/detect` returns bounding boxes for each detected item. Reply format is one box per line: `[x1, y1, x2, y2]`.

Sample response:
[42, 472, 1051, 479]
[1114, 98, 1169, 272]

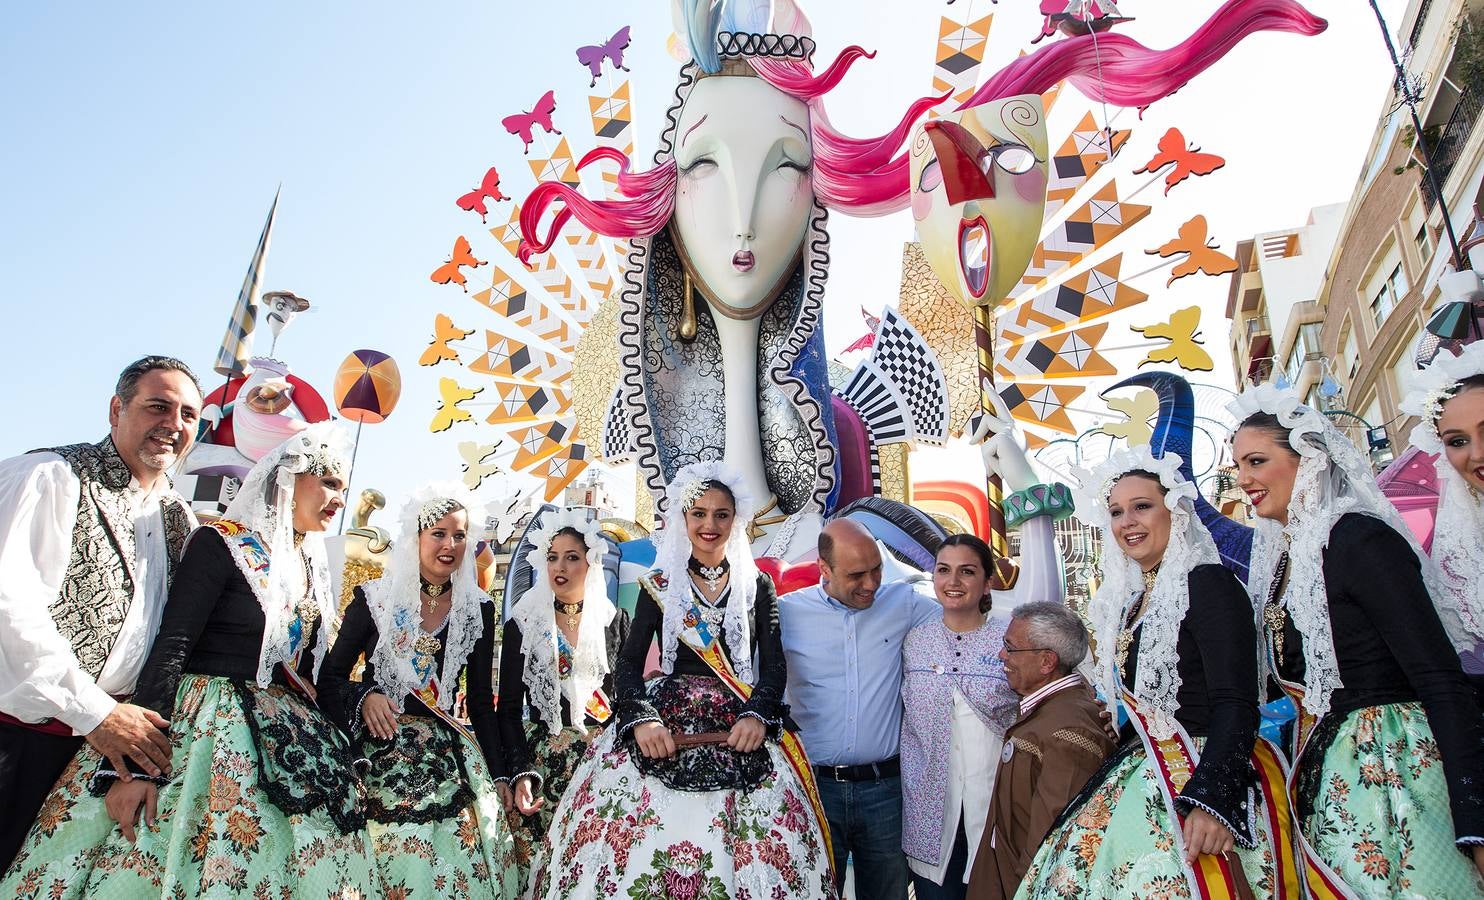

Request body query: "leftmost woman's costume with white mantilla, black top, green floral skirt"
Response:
[0, 426, 375, 899]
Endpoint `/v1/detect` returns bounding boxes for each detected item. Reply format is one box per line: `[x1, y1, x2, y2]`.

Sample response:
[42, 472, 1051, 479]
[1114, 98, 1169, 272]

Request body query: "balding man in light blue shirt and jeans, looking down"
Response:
[778, 520, 942, 900]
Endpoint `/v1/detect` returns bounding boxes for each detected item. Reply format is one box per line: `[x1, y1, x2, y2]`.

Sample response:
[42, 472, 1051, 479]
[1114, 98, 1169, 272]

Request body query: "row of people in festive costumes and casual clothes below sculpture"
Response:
[0, 343, 1484, 900]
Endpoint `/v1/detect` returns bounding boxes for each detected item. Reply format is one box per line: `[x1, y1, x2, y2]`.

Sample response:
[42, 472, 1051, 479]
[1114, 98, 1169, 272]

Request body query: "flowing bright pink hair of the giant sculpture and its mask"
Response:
[519, 0, 1327, 264]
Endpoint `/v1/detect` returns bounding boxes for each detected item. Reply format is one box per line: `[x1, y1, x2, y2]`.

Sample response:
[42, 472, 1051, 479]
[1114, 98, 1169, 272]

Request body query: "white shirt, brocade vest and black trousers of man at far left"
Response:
[0, 438, 196, 873]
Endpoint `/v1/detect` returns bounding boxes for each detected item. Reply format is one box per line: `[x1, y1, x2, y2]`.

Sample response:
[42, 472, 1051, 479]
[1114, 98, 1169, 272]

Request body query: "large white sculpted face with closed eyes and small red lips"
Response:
[675, 76, 815, 319]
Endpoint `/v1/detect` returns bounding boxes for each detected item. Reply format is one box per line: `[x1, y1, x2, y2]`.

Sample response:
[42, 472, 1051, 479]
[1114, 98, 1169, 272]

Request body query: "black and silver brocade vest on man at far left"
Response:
[33, 438, 191, 679]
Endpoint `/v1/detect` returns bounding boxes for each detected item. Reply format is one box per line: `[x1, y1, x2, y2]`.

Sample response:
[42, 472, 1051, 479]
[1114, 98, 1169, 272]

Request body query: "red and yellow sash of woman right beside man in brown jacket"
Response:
[1123, 689, 1304, 900]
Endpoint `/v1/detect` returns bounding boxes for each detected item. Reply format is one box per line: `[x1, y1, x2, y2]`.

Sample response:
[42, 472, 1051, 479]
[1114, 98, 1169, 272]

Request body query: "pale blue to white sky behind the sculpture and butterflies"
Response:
[0, 0, 1404, 519]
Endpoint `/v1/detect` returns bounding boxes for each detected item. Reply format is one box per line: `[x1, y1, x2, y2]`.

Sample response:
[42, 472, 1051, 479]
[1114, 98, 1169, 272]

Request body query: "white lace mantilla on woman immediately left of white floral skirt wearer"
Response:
[510, 509, 619, 734]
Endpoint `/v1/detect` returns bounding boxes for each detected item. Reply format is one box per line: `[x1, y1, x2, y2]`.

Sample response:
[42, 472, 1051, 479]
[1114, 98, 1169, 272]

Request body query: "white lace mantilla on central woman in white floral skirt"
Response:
[653, 462, 757, 682]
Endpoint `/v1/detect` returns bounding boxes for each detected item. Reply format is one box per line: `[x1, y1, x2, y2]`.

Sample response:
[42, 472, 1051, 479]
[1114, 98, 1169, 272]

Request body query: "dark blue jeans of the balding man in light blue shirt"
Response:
[818, 777, 908, 900]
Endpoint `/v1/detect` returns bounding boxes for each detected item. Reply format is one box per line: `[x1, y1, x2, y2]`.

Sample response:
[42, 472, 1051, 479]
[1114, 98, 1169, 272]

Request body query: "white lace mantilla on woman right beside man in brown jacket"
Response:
[1076, 446, 1221, 740]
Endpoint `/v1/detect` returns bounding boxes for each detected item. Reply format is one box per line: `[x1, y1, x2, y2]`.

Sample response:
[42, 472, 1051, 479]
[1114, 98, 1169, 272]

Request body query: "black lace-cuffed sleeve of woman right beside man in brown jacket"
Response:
[1175, 566, 1258, 848]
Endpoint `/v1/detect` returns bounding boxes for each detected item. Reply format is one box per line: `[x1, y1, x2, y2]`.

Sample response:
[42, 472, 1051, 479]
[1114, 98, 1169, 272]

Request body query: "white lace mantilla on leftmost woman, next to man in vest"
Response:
[224, 422, 350, 688]
